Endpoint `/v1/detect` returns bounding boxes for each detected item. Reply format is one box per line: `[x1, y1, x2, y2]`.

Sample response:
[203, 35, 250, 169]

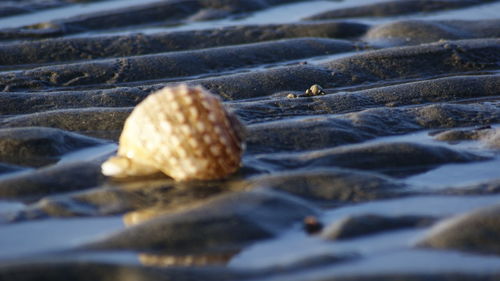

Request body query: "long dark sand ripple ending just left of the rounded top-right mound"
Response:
[0, 21, 367, 69]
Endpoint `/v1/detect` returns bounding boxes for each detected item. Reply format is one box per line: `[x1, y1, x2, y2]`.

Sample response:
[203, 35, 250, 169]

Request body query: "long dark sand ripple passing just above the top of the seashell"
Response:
[0, 38, 356, 91]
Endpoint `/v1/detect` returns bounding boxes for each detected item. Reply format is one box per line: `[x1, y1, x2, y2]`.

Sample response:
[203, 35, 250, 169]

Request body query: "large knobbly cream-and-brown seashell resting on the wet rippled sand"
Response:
[101, 84, 244, 181]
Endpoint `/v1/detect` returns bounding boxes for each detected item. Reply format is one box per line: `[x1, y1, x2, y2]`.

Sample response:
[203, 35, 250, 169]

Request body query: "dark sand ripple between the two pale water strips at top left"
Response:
[0, 0, 312, 40]
